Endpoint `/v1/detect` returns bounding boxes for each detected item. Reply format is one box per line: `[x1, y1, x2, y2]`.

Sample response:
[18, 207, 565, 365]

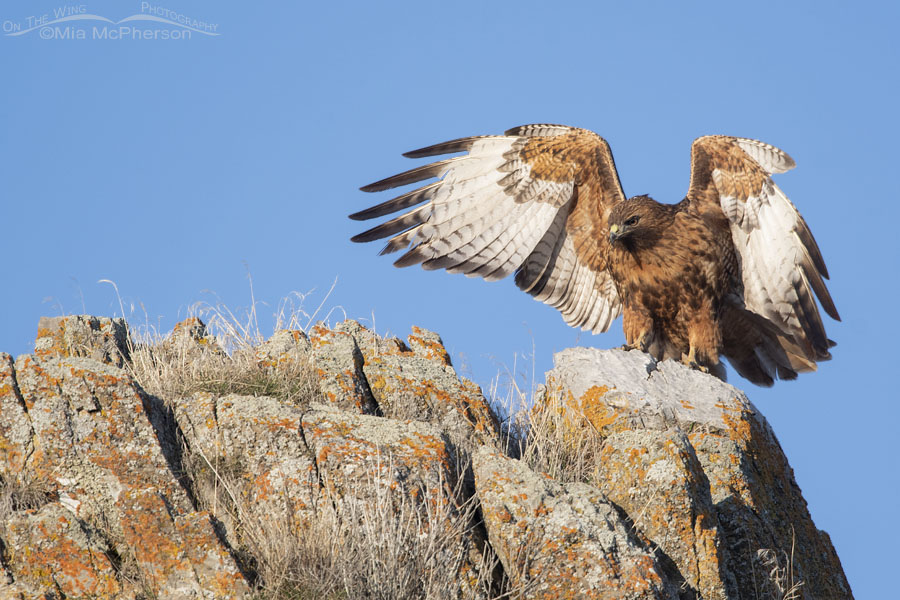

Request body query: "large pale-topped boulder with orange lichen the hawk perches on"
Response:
[547, 348, 852, 600]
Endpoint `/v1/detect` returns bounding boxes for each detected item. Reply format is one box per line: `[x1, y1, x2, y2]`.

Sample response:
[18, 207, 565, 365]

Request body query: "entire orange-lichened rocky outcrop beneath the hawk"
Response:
[0, 316, 852, 600]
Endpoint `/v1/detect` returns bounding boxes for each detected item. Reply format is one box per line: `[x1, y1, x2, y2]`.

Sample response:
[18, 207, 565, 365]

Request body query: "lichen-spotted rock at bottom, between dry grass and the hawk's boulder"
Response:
[474, 448, 678, 600]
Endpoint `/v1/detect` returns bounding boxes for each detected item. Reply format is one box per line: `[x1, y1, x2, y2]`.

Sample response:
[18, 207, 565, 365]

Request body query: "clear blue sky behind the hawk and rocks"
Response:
[0, 0, 900, 598]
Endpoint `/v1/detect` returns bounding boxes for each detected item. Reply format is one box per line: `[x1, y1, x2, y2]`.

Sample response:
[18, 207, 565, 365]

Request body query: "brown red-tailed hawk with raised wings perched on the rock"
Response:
[350, 125, 840, 386]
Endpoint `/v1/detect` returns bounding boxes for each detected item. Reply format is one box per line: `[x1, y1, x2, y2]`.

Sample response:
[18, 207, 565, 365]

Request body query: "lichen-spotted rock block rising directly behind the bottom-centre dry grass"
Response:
[302, 405, 484, 600]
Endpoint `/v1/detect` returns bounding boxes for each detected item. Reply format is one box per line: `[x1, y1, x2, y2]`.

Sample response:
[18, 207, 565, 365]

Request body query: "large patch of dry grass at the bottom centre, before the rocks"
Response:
[188, 446, 508, 600]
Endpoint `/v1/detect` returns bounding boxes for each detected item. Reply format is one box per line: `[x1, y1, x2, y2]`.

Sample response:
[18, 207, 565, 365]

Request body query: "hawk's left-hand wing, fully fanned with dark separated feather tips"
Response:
[350, 125, 624, 333]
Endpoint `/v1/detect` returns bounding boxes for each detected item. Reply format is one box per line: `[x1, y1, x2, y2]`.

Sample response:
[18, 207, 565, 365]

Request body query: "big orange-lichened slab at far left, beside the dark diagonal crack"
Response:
[0, 355, 249, 598]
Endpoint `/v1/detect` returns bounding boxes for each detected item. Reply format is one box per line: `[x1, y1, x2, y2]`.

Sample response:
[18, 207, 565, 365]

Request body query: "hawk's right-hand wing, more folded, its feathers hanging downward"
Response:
[687, 135, 840, 370]
